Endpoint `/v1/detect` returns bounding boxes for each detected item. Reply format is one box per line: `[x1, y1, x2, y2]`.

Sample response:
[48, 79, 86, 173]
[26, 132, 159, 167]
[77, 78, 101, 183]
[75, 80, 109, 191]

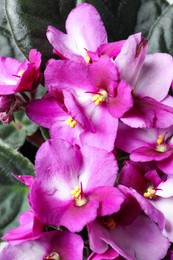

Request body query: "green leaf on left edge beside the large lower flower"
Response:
[0, 140, 35, 235]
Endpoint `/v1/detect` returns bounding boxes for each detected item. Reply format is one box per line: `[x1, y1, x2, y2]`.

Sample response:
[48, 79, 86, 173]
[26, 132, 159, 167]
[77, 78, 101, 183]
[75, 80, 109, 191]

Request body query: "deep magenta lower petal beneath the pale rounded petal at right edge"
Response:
[121, 97, 173, 128]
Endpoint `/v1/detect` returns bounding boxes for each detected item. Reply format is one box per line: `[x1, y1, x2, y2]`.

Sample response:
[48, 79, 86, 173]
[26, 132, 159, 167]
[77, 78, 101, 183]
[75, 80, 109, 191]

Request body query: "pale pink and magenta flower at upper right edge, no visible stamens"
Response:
[114, 33, 173, 128]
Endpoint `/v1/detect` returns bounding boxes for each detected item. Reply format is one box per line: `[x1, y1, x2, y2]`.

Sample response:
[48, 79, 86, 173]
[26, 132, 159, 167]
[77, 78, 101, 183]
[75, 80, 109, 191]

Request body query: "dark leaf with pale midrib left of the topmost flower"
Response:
[5, 0, 75, 66]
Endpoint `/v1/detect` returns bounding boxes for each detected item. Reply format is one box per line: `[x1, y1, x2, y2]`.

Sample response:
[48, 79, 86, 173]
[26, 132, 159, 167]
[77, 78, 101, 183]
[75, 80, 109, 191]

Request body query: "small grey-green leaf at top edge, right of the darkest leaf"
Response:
[135, 0, 169, 38]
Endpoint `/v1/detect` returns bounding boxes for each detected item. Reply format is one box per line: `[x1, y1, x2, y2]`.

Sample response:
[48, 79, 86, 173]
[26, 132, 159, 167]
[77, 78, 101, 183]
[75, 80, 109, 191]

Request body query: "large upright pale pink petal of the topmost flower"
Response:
[66, 3, 107, 55]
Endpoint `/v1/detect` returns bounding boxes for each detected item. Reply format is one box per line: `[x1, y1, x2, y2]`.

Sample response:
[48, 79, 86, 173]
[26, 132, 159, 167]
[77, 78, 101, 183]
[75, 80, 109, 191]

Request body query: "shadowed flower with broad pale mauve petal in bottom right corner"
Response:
[88, 186, 170, 260]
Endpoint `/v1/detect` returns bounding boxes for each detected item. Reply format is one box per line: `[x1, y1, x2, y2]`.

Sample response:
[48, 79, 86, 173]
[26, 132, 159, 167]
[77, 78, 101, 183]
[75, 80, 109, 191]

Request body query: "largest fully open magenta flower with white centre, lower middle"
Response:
[30, 139, 124, 232]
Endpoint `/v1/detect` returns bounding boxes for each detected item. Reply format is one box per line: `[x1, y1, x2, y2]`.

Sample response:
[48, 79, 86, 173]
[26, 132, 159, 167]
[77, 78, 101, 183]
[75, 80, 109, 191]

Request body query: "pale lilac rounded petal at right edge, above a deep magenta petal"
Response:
[134, 53, 173, 101]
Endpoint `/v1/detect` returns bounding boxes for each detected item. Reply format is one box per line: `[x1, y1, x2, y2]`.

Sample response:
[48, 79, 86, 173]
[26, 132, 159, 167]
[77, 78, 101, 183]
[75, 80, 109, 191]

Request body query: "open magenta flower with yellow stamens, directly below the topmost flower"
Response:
[45, 56, 132, 151]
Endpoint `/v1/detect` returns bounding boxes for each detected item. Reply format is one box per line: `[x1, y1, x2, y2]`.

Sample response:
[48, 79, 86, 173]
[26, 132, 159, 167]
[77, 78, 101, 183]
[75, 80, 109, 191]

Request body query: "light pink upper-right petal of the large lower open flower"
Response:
[80, 146, 118, 193]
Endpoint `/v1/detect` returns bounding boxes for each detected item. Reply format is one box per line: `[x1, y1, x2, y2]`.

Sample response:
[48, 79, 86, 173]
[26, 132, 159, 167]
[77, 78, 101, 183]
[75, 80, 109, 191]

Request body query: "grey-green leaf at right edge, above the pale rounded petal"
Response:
[149, 5, 173, 55]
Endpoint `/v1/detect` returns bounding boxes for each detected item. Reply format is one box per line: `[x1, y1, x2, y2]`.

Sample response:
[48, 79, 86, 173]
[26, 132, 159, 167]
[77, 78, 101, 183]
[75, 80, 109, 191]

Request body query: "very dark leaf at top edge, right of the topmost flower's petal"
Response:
[78, 0, 141, 41]
